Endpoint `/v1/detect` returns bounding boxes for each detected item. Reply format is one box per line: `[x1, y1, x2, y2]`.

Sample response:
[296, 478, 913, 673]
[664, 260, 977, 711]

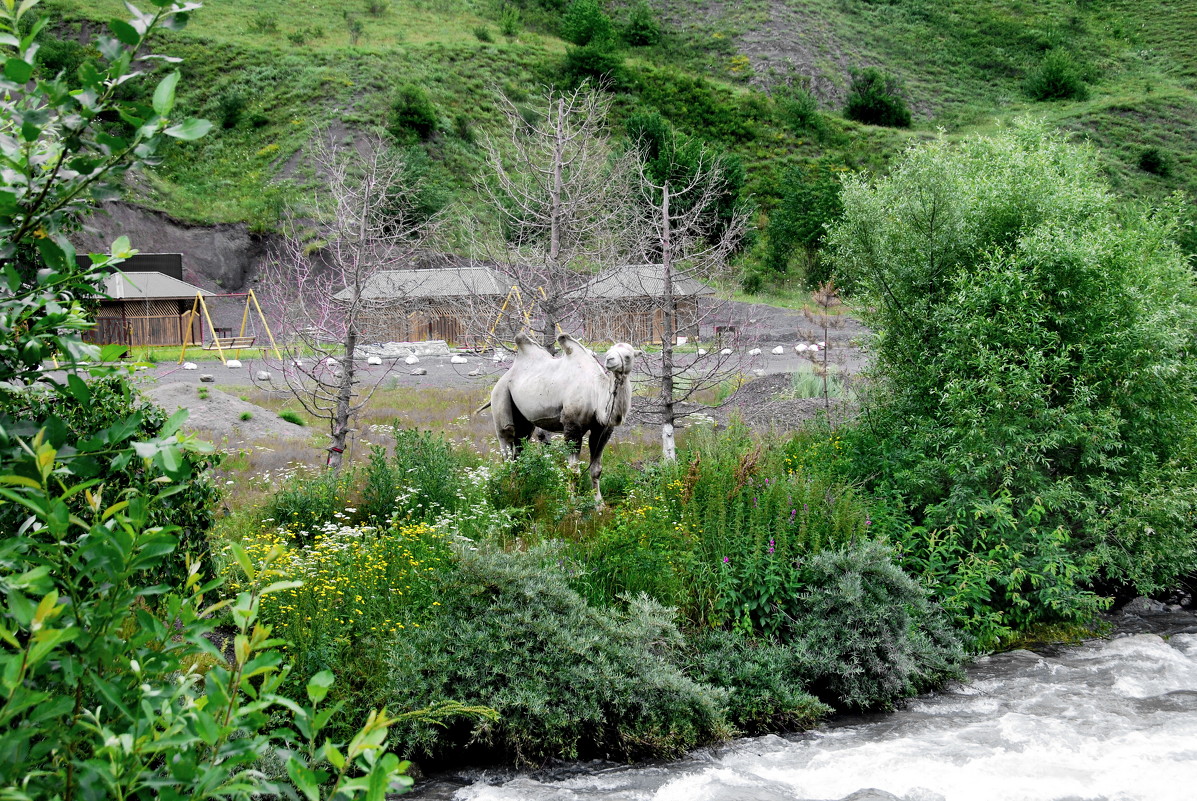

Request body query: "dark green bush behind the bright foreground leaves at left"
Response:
[0, 376, 220, 585]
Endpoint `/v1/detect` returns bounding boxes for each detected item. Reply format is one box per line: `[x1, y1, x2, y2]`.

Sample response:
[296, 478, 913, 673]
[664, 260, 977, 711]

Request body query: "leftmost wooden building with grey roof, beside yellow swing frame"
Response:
[84, 253, 212, 346]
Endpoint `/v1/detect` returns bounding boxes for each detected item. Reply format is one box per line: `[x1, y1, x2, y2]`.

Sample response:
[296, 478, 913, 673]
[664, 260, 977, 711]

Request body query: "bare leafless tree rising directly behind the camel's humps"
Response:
[473, 89, 634, 348]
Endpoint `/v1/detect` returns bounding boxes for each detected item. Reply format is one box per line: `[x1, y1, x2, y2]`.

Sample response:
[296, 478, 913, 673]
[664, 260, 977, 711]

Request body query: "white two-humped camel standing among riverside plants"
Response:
[478, 334, 640, 505]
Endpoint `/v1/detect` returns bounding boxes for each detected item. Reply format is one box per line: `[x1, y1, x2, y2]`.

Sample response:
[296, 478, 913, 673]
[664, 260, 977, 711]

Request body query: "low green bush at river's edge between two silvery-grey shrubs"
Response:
[686, 629, 832, 735]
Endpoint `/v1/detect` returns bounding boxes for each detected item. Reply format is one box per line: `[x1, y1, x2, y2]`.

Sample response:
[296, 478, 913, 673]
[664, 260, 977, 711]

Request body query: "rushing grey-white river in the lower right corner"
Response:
[415, 611, 1197, 801]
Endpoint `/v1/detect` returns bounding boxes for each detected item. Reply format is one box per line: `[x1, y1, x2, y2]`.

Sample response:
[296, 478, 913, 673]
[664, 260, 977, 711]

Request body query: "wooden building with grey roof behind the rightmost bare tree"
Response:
[577, 265, 715, 345]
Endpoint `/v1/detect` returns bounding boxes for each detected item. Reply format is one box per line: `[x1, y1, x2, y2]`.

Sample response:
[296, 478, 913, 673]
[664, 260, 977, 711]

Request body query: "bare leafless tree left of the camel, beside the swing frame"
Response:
[261, 134, 438, 471]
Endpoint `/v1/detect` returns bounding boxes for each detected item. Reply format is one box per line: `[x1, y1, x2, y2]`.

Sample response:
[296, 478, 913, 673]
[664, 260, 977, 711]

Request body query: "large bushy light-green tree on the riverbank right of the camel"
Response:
[828, 122, 1197, 641]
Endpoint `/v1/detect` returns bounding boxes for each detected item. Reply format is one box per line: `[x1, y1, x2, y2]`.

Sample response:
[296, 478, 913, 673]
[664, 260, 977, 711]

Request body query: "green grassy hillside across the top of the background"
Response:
[43, 0, 1197, 256]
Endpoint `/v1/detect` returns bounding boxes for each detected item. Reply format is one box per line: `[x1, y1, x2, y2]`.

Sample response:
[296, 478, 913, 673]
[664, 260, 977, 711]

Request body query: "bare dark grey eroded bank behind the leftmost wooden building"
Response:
[75, 202, 269, 292]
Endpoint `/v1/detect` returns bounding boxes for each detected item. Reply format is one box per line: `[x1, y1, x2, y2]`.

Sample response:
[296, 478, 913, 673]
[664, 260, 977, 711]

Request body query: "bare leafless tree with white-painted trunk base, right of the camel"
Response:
[637, 140, 748, 459]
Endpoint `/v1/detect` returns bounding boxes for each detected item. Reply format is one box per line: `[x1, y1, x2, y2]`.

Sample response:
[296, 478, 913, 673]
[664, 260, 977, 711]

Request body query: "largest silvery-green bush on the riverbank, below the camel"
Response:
[390, 552, 729, 765]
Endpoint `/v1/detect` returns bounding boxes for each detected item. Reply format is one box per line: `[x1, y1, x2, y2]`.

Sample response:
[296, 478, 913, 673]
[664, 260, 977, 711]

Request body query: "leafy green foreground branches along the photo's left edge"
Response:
[0, 0, 409, 799]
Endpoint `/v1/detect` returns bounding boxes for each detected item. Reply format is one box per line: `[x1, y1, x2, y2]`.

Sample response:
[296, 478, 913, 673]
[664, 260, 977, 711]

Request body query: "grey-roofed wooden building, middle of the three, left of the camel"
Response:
[333, 257, 511, 346]
